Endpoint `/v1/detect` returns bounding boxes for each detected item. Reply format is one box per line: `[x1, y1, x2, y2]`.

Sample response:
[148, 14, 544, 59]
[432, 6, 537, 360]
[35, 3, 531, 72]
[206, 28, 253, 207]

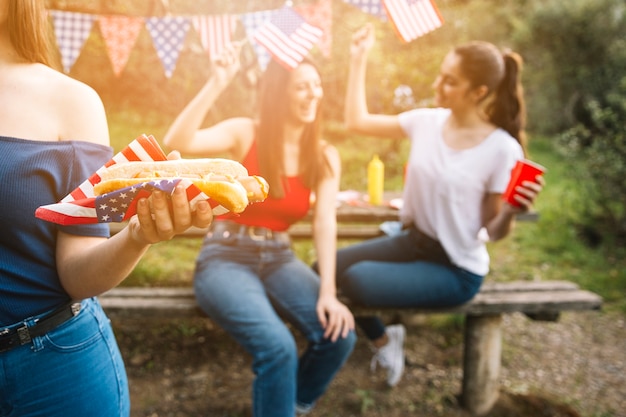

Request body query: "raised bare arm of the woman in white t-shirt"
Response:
[344, 25, 405, 138]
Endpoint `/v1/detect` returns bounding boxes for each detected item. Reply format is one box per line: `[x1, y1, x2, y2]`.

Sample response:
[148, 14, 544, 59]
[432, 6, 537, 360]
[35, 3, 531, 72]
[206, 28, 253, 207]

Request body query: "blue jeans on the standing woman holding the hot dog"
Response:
[0, 299, 130, 417]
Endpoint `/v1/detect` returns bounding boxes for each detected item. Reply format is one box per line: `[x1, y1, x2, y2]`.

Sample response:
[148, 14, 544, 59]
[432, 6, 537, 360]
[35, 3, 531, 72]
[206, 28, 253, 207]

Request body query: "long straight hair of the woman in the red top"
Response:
[257, 59, 329, 198]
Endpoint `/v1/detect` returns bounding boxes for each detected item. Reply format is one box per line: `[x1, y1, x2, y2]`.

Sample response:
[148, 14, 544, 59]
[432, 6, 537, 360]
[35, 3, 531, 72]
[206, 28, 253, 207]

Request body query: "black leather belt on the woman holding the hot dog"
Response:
[0, 302, 81, 353]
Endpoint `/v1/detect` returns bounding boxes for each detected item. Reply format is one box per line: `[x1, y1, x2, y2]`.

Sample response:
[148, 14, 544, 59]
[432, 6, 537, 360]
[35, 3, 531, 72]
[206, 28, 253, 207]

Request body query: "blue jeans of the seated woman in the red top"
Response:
[194, 235, 356, 417]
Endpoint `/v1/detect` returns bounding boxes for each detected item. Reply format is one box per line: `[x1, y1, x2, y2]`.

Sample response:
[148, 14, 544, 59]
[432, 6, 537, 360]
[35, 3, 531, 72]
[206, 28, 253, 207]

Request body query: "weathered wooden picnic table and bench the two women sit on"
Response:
[100, 197, 588, 415]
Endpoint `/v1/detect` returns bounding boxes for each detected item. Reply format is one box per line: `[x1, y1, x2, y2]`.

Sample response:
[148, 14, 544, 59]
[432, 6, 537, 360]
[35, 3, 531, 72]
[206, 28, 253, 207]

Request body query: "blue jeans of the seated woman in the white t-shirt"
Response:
[337, 227, 483, 340]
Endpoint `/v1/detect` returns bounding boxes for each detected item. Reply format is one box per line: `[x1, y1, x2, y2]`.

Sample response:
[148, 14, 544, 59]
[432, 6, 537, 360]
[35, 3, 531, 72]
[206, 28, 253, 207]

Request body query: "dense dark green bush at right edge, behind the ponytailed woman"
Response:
[510, 0, 626, 245]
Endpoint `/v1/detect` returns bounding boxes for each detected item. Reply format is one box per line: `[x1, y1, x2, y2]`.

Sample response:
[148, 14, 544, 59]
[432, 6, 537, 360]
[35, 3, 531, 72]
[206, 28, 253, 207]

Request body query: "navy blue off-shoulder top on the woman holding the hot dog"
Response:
[0, 136, 113, 328]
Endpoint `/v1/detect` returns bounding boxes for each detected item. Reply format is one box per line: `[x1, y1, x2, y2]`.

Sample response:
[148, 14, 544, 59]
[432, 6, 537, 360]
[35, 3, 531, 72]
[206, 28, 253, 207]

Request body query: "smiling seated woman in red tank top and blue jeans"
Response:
[165, 45, 356, 417]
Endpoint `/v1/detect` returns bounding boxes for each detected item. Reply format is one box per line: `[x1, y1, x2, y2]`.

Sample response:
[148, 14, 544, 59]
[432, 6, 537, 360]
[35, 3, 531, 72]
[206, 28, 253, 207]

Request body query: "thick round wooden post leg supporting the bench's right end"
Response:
[461, 314, 502, 416]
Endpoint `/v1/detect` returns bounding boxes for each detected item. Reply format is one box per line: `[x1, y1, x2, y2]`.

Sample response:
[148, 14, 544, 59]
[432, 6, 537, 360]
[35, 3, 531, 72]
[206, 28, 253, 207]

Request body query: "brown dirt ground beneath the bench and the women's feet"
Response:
[112, 312, 626, 417]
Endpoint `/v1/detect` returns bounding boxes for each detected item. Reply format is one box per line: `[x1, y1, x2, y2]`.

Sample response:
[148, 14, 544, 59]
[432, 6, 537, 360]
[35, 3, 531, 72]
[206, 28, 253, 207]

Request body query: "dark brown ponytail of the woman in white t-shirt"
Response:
[487, 52, 526, 149]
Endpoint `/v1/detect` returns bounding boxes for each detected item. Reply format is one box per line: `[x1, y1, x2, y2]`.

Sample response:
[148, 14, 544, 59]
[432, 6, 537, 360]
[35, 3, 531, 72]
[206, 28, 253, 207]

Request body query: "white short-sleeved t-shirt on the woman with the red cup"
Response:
[399, 109, 523, 275]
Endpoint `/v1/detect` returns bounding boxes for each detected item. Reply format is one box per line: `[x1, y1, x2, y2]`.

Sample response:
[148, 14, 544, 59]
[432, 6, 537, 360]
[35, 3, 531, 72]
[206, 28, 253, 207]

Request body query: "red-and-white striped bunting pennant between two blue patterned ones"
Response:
[191, 14, 239, 57]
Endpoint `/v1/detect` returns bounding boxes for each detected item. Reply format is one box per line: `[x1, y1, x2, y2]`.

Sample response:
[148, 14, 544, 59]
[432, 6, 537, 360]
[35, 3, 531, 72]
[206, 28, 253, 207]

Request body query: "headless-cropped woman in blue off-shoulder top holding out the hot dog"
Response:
[0, 0, 212, 417]
